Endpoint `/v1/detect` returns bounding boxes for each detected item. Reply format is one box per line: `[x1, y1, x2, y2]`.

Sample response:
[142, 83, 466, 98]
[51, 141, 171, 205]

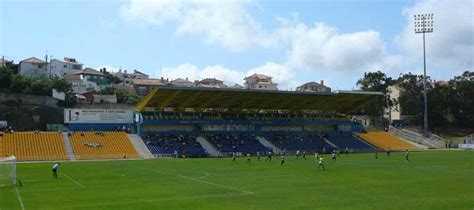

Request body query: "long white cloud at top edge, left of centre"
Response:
[121, 0, 275, 51]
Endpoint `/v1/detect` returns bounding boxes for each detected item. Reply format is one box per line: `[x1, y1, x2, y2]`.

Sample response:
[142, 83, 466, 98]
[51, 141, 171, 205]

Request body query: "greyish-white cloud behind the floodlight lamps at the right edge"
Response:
[396, 0, 474, 71]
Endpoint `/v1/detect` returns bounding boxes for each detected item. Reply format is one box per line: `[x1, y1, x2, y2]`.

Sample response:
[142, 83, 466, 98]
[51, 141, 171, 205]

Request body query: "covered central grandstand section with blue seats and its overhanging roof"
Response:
[135, 87, 381, 157]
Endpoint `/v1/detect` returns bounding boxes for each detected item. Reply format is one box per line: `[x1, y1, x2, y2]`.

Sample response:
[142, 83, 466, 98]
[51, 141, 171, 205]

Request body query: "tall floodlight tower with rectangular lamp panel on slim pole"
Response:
[414, 14, 433, 136]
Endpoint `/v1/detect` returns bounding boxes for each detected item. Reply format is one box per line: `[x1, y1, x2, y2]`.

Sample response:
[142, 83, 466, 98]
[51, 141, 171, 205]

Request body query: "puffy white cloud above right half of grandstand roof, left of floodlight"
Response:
[279, 23, 394, 71]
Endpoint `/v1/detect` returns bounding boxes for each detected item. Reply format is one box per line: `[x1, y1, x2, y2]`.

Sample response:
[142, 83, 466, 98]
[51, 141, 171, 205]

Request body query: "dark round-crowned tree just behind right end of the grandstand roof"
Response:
[357, 71, 397, 116]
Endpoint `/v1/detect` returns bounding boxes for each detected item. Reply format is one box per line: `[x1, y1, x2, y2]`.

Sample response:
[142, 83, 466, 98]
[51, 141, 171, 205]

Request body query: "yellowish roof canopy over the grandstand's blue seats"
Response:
[135, 87, 382, 114]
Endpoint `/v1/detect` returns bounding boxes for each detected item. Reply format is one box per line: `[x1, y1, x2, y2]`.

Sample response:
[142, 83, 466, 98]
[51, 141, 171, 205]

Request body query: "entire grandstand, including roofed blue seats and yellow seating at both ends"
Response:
[0, 87, 421, 160]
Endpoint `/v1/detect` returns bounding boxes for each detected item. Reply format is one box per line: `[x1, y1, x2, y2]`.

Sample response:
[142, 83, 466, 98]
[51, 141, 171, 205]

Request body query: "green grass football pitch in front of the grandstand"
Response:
[0, 151, 474, 210]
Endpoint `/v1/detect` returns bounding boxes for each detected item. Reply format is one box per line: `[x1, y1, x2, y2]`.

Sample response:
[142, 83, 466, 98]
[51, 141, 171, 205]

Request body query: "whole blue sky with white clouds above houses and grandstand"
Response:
[0, 0, 474, 90]
